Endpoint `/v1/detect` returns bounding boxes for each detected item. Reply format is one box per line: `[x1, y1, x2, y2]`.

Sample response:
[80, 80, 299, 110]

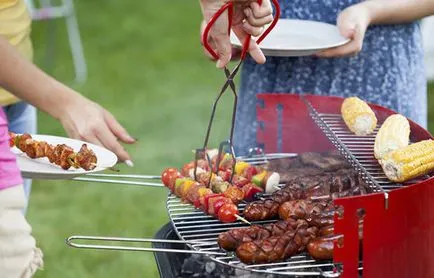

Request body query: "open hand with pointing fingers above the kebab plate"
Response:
[59, 96, 136, 167]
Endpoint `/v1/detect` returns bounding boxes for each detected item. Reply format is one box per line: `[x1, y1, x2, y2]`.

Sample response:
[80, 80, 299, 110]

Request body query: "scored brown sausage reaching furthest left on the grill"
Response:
[218, 219, 308, 251]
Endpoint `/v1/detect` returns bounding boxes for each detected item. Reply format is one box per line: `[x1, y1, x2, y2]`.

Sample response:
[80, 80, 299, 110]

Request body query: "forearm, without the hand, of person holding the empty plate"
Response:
[358, 0, 434, 24]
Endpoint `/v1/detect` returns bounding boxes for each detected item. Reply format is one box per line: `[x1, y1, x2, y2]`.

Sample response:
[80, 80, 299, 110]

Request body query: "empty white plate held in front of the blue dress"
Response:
[231, 19, 350, 57]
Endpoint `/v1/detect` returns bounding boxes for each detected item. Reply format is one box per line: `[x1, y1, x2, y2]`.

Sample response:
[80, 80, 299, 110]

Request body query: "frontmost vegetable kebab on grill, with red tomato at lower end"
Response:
[161, 168, 250, 224]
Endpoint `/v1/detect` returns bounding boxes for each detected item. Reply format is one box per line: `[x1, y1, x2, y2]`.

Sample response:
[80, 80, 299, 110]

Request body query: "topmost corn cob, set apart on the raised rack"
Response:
[341, 97, 377, 135]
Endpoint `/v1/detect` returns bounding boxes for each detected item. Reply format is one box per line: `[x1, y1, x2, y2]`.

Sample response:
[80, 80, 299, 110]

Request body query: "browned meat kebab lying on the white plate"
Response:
[9, 132, 97, 171]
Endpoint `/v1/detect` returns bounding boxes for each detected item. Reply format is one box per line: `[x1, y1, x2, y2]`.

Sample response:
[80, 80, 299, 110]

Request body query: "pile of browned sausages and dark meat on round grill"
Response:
[218, 153, 369, 264]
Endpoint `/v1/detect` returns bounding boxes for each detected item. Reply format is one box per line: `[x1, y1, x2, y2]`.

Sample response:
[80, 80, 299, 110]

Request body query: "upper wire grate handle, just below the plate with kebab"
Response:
[72, 174, 164, 187]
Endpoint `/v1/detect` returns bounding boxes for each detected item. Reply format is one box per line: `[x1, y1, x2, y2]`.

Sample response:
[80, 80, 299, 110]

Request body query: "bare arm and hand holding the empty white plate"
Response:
[317, 0, 434, 58]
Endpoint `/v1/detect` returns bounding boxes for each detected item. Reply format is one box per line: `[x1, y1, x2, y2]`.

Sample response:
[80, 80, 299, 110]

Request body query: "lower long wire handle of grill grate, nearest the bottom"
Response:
[66, 236, 227, 256]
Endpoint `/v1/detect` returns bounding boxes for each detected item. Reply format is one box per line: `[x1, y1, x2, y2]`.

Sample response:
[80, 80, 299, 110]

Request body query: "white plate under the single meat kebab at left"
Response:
[11, 134, 118, 179]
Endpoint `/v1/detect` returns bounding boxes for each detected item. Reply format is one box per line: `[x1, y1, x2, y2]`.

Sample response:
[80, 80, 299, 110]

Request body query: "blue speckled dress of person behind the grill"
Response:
[234, 0, 427, 155]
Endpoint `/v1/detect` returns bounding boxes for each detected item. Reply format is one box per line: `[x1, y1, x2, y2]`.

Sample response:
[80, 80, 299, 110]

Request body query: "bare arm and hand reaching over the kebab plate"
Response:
[0, 36, 135, 166]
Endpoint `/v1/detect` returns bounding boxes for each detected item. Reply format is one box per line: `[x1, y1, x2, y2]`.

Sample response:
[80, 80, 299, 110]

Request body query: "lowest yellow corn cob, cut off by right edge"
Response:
[380, 140, 434, 182]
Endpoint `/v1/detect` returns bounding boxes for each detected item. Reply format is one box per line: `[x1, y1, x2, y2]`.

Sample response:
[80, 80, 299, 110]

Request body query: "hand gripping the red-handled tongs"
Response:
[201, 0, 273, 68]
